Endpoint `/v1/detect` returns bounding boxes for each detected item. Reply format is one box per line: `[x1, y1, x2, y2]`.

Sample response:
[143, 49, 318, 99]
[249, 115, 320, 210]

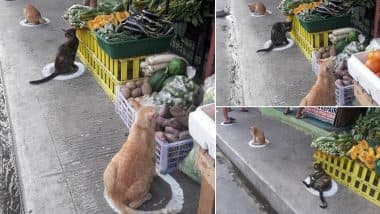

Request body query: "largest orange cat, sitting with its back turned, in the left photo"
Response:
[103, 100, 157, 214]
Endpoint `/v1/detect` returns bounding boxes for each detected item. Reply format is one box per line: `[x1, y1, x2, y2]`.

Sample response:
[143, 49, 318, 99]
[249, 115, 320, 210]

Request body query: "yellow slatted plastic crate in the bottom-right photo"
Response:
[314, 151, 380, 206]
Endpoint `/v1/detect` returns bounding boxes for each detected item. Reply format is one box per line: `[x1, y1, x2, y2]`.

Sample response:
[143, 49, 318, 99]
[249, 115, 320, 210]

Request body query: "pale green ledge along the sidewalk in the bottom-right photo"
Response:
[260, 107, 330, 137]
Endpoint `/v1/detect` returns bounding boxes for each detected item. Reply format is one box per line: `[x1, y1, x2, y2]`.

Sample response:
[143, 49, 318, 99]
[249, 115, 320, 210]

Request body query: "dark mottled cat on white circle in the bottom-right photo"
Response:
[302, 163, 332, 209]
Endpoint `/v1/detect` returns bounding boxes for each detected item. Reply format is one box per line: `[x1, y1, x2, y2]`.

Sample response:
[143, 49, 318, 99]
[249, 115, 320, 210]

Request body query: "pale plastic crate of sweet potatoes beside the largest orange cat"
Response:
[156, 138, 193, 173]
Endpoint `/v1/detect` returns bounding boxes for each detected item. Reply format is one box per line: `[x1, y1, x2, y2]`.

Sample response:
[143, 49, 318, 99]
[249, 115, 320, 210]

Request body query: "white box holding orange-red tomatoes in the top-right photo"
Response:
[347, 52, 380, 103]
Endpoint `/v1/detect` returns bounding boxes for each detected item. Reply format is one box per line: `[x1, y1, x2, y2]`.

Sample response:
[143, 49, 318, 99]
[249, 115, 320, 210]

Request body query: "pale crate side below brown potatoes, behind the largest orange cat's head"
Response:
[115, 86, 135, 130]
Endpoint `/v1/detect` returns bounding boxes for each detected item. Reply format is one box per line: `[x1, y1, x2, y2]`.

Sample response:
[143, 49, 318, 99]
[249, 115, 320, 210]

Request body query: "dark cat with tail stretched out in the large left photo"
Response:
[29, 29, 79, 85]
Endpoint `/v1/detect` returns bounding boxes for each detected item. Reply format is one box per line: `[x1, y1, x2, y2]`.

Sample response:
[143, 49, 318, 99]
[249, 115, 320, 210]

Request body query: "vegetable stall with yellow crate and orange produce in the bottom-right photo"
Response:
[311, 108, 380, 206]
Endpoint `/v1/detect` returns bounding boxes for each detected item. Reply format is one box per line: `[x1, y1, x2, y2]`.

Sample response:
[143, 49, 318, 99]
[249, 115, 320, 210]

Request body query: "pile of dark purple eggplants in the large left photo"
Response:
[122, 10, 174, 38]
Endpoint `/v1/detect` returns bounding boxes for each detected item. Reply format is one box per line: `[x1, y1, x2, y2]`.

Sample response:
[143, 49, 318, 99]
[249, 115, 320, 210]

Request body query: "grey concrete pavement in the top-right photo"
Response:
[216, 0, 316, 106]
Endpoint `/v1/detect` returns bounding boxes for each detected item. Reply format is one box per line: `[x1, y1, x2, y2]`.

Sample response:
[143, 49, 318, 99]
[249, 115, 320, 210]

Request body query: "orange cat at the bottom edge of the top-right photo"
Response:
[297, 59, 336, 117]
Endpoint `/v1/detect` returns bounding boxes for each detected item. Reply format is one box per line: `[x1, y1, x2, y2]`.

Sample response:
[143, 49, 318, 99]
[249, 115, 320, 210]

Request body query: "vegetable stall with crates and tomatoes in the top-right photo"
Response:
[278, 0, 380, 106]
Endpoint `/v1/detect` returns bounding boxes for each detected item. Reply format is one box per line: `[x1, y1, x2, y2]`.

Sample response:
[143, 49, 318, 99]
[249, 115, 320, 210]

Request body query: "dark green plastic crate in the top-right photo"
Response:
[299, 15, 350, 33]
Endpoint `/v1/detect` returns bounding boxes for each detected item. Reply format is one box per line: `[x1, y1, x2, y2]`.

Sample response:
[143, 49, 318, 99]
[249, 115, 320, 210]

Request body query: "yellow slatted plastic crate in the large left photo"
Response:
[76, 29, 145, 100]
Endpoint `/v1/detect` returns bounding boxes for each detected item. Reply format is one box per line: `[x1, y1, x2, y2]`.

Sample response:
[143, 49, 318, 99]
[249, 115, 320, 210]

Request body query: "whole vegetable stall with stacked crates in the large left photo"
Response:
[63, 0, 215, 211]
